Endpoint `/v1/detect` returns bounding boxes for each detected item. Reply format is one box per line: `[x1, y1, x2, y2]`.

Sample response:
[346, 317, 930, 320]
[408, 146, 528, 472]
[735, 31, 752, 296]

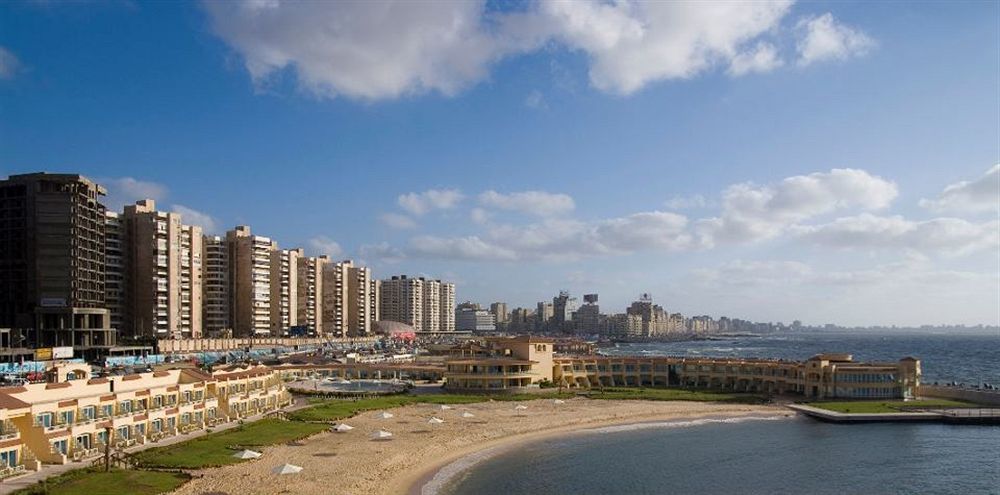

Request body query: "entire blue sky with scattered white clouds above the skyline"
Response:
[0, 0, 1000, 325]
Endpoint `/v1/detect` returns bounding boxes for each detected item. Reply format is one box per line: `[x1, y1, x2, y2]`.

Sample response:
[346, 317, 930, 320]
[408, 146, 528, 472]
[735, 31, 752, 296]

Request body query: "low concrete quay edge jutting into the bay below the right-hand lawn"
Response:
[785, 404, 1000, 425]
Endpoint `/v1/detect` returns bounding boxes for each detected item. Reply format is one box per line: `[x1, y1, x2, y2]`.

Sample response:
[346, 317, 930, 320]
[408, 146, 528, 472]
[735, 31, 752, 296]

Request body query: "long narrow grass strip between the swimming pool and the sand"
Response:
[289, 392, 573, 421]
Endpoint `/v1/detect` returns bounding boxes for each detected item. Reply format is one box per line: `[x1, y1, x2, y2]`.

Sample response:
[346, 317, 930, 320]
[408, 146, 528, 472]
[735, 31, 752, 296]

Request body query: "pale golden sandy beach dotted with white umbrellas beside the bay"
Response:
[175, 398, 791, 495]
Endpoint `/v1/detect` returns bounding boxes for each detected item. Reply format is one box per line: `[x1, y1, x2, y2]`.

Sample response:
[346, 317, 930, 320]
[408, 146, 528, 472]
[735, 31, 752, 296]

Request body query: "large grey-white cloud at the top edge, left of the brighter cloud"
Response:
[202, 0, 532, 100]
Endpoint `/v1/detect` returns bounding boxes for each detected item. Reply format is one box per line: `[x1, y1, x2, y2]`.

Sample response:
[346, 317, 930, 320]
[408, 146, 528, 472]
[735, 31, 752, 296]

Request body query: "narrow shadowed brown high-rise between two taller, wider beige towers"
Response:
[201, 236, 233, 337]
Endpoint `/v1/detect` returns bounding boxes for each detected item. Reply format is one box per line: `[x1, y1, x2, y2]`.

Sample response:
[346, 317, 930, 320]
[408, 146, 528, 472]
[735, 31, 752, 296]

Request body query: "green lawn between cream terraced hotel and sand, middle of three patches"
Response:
[136, 419, 326, 469]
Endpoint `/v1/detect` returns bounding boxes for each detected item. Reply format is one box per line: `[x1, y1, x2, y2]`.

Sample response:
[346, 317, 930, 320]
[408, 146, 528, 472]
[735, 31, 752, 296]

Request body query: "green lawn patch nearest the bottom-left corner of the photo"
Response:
[15, 469, 191, 495]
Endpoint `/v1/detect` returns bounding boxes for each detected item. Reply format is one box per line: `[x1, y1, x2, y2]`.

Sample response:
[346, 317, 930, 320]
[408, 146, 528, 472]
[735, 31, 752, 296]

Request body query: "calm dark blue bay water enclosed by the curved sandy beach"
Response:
[438, 418, 1000, 495]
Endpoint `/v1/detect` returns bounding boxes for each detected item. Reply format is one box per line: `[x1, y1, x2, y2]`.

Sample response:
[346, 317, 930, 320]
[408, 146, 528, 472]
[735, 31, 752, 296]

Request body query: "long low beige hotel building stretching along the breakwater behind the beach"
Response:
[445, 336, 921, 399]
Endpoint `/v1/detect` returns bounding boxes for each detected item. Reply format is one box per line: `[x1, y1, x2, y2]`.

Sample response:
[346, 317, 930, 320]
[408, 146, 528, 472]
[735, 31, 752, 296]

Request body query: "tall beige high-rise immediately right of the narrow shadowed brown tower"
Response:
[226, 225, 275, 337]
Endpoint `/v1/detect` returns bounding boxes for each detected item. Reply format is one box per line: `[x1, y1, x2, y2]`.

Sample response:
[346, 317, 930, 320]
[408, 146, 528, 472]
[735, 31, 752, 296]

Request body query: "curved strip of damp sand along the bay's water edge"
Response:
[402, 410, 796, 495]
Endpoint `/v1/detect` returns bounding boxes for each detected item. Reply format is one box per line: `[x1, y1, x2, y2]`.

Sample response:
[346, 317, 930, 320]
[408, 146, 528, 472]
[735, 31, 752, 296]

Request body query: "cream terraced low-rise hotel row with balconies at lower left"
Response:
[0, 363, 291, 478]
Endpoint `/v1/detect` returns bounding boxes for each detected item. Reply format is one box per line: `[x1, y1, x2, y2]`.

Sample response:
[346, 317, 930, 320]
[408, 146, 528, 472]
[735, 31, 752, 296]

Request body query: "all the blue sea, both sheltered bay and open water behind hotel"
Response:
[436, 332, 1000, 495]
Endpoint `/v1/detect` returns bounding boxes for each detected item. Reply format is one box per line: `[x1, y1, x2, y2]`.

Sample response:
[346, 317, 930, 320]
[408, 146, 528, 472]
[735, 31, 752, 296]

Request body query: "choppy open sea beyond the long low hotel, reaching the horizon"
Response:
[602, 332, 1000, 385]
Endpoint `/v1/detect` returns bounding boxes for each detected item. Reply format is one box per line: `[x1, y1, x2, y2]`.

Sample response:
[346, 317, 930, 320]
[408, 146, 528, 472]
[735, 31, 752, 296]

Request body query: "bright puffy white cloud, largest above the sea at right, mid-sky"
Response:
[696, 169, 899, 245]
